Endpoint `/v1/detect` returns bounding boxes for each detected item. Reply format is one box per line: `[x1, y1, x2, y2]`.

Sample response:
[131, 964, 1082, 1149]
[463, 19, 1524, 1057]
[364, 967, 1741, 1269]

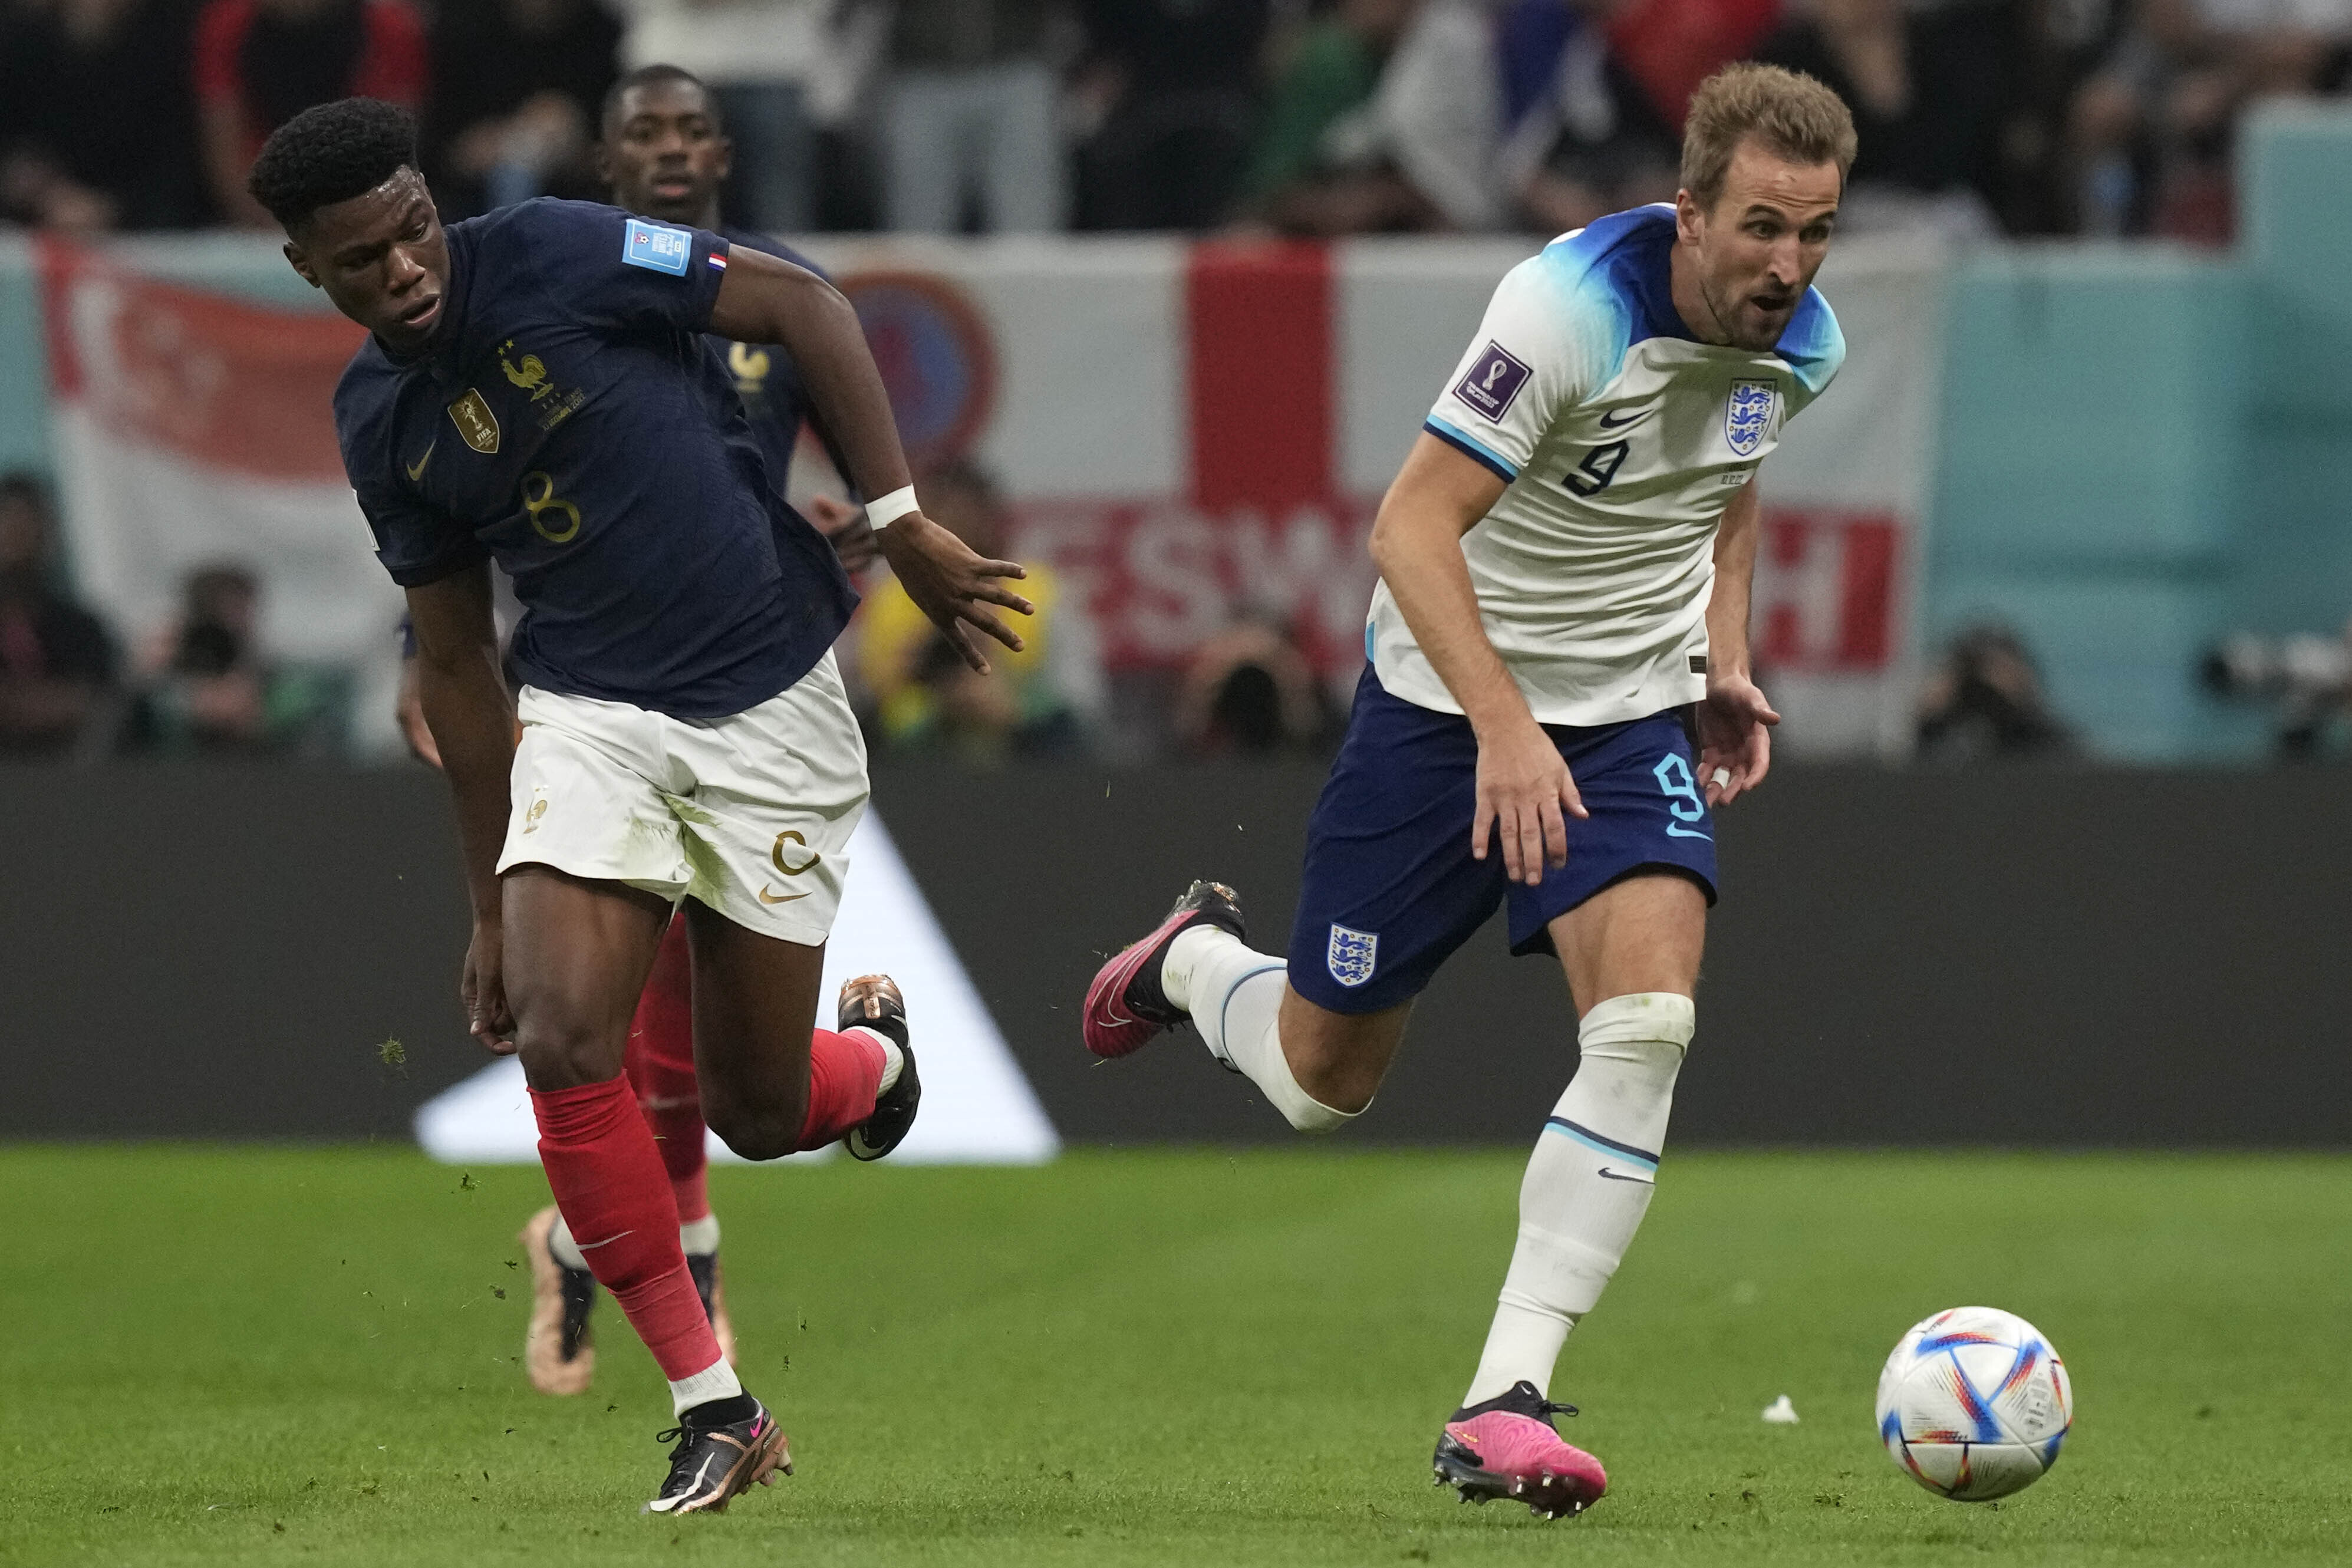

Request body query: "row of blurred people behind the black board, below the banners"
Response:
[0, 461, 2352, 769]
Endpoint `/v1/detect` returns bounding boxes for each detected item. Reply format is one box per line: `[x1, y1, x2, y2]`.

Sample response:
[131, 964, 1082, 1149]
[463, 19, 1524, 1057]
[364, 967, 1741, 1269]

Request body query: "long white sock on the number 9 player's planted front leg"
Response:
[1463, 992, 1698, 1406]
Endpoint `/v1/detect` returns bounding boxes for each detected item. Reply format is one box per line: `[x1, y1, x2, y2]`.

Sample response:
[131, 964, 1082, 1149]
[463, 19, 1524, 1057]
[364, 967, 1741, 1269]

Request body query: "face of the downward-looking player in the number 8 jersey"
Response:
[287, 169, 449, 353]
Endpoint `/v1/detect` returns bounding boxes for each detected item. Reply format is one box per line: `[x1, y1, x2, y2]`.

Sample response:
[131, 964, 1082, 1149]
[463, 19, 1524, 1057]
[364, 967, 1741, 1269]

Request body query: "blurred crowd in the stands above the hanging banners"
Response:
[0, 0, 2352, 242]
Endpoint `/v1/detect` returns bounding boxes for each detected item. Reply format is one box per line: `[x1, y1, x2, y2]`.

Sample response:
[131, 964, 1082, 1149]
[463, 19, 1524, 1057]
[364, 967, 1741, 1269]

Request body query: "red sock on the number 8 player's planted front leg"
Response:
[532, 1077, 720, 1382]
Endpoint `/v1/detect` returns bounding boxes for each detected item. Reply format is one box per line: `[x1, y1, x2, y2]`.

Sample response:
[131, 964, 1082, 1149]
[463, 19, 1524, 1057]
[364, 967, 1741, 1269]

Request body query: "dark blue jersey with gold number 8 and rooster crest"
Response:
[334, 200, 856, 719]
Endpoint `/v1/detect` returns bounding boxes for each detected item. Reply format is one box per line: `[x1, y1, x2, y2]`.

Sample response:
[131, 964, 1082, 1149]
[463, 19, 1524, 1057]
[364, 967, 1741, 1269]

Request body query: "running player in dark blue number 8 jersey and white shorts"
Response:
[249, 98, 1026, 1514]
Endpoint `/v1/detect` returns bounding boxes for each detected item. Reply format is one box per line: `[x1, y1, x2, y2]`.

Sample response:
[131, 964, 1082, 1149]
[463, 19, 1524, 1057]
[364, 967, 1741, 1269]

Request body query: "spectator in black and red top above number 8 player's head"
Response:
[195, 0, 426, 230]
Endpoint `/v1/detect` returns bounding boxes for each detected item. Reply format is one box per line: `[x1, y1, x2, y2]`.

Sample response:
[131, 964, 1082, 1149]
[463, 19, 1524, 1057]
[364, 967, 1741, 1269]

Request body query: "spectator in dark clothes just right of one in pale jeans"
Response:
[1075, 0, 1273, 230]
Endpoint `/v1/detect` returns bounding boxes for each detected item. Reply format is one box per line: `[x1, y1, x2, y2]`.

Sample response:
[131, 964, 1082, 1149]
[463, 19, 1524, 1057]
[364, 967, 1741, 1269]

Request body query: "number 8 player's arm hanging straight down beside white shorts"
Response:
[409, 562, 515, 1056]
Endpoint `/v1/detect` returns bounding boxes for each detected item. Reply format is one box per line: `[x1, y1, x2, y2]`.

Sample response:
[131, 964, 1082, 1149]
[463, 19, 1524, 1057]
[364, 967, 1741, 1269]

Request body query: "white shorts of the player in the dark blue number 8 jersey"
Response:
[499, 651, 868, 947]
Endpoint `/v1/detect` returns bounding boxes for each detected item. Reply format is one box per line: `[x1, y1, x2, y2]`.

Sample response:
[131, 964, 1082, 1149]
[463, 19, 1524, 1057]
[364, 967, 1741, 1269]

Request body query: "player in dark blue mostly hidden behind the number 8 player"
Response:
[400, 66, 889, 1394]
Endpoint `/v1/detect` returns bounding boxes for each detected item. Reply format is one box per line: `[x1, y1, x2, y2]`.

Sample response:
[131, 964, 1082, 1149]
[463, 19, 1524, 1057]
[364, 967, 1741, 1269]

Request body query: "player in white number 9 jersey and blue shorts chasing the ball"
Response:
[1084, 66, 1856, 1516]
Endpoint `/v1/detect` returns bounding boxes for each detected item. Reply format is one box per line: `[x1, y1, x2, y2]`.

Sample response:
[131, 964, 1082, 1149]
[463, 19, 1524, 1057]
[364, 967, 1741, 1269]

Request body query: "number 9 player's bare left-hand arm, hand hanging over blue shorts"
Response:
[1371, 433, 1585, 886]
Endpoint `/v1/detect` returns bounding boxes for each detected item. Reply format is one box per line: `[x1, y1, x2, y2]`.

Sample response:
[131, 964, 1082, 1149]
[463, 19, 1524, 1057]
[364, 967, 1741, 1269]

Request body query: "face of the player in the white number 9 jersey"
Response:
[1675, 141, 1844, 350]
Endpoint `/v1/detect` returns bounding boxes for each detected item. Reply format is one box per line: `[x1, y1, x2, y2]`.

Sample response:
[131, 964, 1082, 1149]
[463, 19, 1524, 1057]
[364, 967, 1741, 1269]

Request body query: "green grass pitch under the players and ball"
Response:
[0, 1145, 2352, 1568]
